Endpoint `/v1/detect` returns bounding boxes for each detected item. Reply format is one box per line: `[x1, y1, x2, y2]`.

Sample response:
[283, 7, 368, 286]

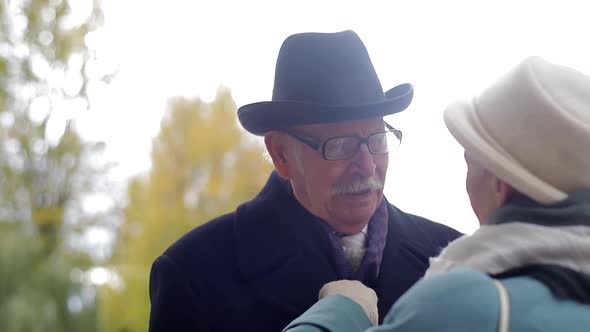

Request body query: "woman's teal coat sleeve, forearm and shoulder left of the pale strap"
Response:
[284, 269, 500, 332]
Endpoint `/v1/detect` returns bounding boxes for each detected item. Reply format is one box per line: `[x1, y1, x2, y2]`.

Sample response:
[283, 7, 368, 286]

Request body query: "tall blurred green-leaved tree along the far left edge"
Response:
[0, 0, 109, 332]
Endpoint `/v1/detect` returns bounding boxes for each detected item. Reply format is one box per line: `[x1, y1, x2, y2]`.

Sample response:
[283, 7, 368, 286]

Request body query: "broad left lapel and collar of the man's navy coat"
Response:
[235, 172, 337, 319]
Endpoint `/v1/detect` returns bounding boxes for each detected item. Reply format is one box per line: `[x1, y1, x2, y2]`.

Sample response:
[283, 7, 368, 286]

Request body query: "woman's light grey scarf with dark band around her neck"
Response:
[426, 189, 590, 277]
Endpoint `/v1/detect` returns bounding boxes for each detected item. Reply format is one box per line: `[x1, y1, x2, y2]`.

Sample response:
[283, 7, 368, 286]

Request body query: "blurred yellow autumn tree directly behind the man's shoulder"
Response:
[101, 89, 272, 332]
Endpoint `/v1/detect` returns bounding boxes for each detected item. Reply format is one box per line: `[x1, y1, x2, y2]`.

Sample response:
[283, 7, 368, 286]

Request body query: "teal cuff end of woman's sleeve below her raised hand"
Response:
[283, 295, 372, 332]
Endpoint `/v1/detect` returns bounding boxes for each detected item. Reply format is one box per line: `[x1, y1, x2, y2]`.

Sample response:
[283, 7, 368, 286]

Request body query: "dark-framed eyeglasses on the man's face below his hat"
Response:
[285, 123, 402, 160]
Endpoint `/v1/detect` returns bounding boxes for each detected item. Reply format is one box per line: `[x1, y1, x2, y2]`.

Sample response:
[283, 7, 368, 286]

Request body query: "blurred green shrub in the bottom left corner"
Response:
[0, 222, 98, 332]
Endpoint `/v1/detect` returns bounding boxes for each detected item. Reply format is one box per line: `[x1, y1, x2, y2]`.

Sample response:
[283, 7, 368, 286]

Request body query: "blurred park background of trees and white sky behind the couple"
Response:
[0, 0, 590, 332]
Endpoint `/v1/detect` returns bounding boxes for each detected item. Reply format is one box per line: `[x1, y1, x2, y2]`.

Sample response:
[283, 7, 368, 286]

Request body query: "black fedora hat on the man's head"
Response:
[238, 31, 414, 135]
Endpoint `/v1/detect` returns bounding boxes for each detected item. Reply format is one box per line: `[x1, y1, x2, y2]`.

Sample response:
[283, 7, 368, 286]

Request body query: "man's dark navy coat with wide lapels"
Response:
[150, 172, 460, 332]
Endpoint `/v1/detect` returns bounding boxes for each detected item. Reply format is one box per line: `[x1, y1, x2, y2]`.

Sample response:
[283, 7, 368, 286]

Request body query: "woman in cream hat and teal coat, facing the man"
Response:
[285, 57, 590, 332]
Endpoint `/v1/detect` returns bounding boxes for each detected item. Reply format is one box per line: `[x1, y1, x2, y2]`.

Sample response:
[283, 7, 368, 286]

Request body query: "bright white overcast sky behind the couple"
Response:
[77, 0, 590, 233]
